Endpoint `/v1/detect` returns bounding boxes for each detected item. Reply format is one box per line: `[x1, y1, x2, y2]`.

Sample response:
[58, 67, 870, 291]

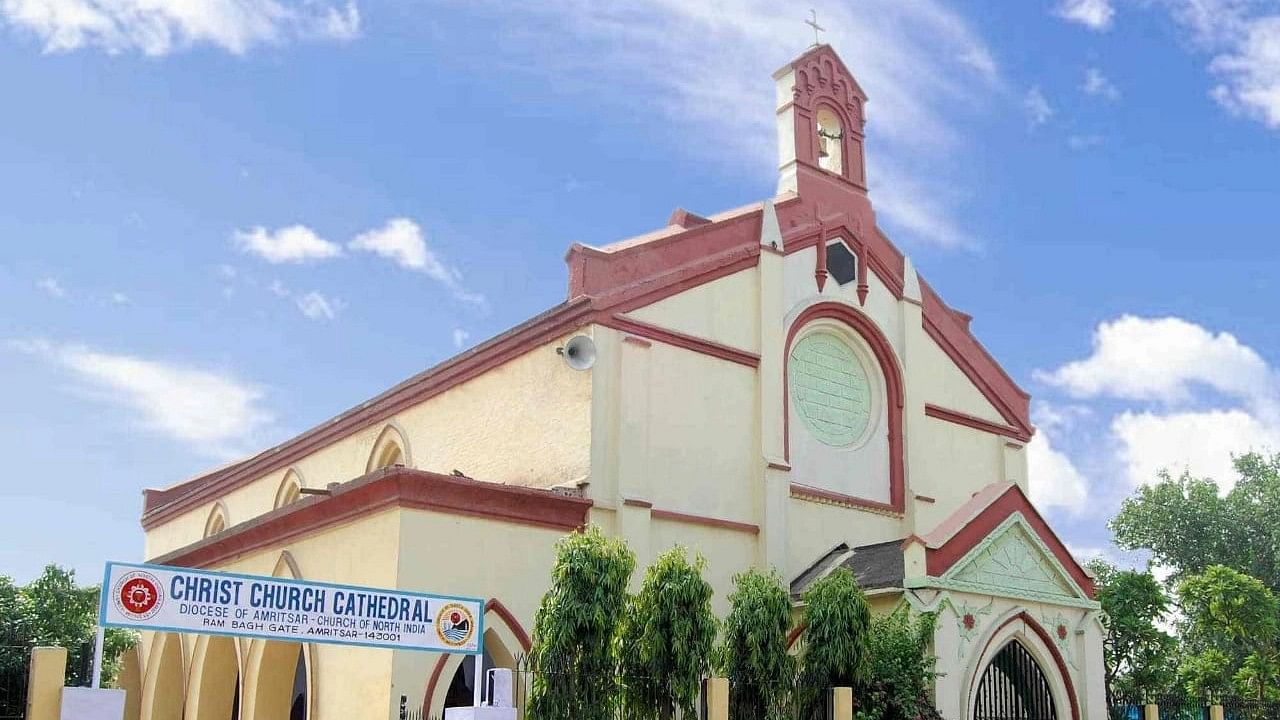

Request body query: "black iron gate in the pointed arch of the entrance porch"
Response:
[973, 641, 1057, 720]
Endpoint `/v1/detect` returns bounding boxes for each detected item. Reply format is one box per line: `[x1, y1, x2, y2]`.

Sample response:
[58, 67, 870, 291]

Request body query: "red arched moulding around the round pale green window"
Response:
[782, 302, 905, 512]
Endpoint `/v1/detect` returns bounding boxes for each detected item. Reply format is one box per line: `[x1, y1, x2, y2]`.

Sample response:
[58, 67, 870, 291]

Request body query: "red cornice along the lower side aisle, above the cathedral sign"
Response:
[150, 468, 591, 568]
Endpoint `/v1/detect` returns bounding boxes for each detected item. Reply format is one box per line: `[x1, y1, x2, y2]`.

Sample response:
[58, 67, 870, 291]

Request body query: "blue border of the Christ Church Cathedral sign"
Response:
[97, 560, 486, 655]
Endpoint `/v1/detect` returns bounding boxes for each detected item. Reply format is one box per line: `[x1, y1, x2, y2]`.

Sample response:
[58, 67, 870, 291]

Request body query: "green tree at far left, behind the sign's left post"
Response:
[0, 565, 137, 684]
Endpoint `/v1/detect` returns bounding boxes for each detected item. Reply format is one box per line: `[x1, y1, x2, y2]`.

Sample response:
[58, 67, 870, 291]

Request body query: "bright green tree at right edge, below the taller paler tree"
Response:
[1178, 565, 1280, 700]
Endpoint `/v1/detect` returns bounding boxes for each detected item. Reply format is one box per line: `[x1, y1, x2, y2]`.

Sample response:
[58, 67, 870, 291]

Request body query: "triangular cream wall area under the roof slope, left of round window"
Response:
[627, 268, 760, 352]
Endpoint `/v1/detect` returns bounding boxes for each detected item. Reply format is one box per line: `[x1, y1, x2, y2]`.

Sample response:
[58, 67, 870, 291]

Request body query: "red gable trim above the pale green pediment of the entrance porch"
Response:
[924, 483, 1093, 598]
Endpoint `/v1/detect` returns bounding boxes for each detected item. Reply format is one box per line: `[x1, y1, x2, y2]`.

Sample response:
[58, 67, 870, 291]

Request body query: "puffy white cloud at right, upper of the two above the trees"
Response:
[1034, 315, 1276, 404]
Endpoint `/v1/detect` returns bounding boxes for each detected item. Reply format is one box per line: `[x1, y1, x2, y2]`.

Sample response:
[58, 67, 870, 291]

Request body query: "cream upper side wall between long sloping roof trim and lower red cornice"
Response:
[146, 338, 591, 557]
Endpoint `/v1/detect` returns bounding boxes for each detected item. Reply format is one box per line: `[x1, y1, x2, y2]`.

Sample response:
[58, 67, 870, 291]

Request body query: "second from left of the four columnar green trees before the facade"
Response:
[618, 546, 717, 720]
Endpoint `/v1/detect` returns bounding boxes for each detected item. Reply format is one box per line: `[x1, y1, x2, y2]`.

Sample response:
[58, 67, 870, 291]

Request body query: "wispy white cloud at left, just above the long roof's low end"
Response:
[9, 341, 274, 456]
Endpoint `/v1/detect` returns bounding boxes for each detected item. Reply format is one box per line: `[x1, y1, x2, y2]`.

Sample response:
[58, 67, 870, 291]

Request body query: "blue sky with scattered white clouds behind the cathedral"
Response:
[0, 0, 1280, 579]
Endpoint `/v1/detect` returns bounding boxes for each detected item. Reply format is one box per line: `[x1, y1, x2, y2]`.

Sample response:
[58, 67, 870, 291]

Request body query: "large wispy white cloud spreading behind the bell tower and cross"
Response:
[455, 0, 1005, 246]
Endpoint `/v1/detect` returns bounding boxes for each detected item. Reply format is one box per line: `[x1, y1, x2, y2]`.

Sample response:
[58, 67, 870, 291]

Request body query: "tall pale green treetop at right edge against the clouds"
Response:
[1111, 452, 1280, 591]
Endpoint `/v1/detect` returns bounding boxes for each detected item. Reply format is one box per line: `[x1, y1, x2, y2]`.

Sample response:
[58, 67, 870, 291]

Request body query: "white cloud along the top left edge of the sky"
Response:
[0, 0, 360, 56]
